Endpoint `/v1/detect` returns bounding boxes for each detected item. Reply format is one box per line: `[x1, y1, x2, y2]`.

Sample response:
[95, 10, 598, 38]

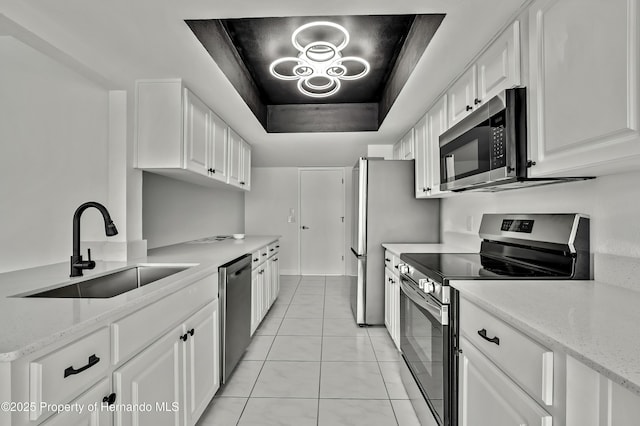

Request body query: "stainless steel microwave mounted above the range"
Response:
[440, 87, 589, 191]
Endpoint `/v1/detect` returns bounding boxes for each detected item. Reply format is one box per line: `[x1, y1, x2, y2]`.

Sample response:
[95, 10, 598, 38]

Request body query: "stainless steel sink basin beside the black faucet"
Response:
[22, 265, 193, 299]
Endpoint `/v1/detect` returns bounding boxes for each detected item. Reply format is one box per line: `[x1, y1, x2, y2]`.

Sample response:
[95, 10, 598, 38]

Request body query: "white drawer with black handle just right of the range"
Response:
[460, 298, 553, 406]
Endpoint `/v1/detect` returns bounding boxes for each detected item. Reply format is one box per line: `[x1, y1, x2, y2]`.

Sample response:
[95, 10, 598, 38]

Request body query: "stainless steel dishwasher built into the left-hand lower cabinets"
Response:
[218, 254, 251, 383]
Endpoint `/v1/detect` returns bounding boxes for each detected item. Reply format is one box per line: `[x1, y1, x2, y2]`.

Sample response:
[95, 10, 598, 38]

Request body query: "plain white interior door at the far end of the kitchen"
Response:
[299, 168, 345, 275]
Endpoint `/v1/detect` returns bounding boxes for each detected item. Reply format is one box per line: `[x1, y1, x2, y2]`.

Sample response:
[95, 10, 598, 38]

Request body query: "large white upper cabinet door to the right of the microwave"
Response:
[529, 0, 640, 176]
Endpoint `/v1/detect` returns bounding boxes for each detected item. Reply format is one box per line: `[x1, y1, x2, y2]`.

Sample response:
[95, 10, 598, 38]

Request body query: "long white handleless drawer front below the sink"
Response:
[111, 273, 218, 365]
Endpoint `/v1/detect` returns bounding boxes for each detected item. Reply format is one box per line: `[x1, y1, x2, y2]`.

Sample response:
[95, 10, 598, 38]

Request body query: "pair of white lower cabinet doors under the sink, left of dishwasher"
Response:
[114, 300, 220, 426]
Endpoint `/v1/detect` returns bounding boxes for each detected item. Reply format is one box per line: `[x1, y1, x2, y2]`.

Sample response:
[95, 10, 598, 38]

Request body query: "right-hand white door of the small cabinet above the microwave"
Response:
[474, 21, 520, 106]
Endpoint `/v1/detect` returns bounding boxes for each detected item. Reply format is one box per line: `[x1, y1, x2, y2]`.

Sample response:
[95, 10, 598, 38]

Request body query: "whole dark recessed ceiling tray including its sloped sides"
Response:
[185, 14, 445, 133]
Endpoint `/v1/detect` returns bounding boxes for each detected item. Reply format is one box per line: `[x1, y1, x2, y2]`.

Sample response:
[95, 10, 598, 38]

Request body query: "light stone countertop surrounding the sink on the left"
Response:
[0, 236, 280, 362]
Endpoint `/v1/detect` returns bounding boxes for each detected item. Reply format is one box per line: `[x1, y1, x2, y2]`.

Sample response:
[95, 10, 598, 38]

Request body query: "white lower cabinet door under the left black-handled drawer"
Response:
[42, 379, 112, 426]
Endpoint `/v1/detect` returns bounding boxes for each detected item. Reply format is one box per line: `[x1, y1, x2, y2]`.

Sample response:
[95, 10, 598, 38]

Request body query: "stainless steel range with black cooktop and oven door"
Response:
[399, 214, 592, 426]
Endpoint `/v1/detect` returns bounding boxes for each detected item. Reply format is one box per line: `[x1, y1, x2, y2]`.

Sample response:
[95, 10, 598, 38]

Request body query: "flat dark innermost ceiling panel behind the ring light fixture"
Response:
[222, 15, 415, 105]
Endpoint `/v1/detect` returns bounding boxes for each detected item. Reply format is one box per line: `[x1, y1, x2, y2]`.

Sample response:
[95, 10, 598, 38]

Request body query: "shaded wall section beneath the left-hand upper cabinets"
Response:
[142, 173, 245, 249]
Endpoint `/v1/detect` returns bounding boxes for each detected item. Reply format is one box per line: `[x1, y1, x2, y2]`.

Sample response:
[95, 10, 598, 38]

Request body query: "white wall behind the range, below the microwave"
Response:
[442, 172, 640, 289]
